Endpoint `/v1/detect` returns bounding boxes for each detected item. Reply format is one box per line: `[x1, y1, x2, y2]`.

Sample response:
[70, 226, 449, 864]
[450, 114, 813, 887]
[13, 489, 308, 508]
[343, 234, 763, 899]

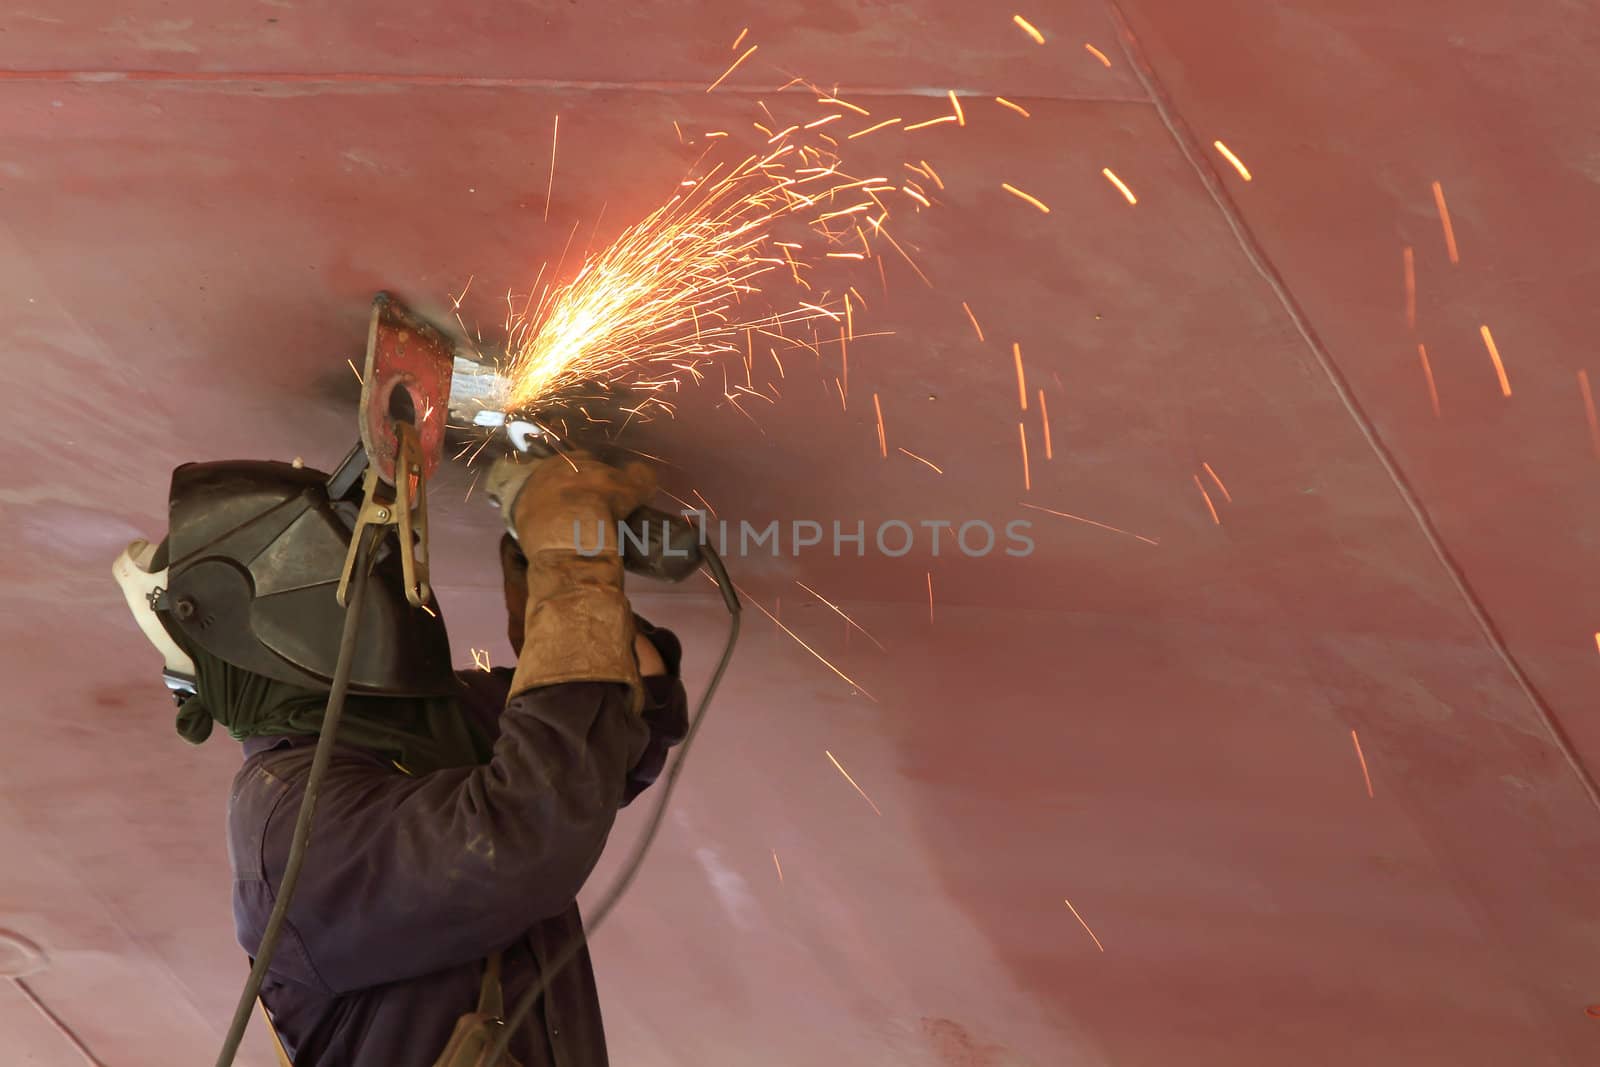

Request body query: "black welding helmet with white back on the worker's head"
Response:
[118, 450, 453, 696]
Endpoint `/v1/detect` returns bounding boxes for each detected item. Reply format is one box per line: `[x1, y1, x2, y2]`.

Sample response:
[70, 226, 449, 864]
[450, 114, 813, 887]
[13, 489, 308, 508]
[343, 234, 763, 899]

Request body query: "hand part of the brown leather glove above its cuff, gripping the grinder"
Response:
[485, 451, 656, 557]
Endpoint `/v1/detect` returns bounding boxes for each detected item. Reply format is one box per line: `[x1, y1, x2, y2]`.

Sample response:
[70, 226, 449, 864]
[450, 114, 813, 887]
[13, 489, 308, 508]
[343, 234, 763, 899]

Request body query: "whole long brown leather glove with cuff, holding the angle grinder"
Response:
[486, 453, 656, 710]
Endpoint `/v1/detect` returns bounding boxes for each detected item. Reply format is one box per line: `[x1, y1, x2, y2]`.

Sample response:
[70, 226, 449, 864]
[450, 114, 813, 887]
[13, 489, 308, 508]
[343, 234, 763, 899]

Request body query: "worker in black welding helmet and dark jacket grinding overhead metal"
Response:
[115, 454, 688, 1067]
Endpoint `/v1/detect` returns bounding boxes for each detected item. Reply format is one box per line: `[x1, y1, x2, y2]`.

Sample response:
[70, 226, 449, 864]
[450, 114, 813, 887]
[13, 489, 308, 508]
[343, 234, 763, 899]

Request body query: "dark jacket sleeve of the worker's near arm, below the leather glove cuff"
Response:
[238, 681, 650, 993]
